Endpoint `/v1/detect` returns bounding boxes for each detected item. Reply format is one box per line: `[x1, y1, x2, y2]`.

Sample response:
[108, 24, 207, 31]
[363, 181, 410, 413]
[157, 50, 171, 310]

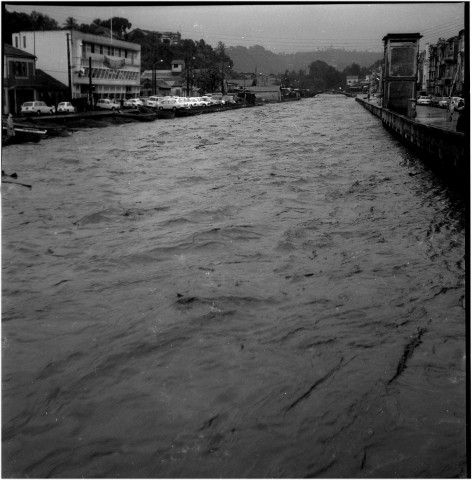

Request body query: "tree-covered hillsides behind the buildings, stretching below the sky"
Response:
[2, 10, 383, 91]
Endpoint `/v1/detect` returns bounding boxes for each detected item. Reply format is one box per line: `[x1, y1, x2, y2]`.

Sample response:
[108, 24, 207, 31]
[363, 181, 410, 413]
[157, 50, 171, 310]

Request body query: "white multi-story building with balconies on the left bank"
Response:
[12, 30, 141, 100]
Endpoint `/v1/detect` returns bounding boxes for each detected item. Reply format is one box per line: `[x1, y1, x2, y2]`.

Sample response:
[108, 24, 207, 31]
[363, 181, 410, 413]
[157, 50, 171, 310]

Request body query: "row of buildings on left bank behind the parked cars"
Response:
[2, 29, 195, 114]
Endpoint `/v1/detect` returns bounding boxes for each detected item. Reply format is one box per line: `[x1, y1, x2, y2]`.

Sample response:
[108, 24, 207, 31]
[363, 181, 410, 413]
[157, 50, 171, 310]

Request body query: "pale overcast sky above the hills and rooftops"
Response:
[4, 2, 464, 53]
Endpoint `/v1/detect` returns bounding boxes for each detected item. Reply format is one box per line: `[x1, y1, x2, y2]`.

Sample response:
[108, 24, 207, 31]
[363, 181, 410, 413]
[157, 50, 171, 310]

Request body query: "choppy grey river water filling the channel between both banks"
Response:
[2, 96, 467, 478]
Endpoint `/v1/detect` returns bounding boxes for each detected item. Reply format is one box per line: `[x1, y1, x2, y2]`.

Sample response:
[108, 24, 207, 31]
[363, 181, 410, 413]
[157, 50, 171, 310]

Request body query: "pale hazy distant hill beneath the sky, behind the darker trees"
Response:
[226, 45, 383, 75]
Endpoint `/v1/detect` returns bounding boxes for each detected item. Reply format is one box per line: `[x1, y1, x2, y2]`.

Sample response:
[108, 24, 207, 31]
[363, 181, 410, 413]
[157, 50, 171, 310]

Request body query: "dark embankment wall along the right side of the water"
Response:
[356, 98, 462, 176]
